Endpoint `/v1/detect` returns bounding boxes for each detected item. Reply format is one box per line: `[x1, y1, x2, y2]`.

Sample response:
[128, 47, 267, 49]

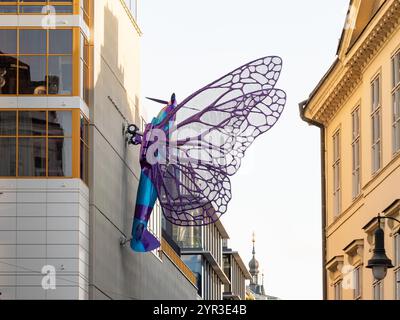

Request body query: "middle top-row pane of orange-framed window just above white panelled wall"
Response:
[18, 111, 46, 136]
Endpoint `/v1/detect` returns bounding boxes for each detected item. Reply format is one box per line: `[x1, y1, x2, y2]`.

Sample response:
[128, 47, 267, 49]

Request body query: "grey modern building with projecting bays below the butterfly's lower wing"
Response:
[166, 221, 251, 300]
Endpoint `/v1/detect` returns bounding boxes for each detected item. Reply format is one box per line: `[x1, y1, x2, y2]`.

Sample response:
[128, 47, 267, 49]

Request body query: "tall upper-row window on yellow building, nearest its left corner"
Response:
[332, 129, 342, 218]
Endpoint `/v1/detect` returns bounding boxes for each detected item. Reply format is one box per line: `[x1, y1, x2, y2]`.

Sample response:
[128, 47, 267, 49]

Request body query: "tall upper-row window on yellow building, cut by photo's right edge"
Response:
[392, 51, 400, 156]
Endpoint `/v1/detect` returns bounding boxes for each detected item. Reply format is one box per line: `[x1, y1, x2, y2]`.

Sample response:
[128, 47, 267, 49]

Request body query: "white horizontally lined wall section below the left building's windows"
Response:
[0, 179, 89, 299]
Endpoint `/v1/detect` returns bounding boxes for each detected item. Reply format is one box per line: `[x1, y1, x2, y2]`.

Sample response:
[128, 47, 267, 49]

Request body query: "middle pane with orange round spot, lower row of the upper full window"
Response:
[19, 56, 46, 95]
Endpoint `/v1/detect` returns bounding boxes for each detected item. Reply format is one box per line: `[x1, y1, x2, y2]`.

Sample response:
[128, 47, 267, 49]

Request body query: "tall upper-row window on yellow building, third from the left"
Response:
[371, 74, 382, 174]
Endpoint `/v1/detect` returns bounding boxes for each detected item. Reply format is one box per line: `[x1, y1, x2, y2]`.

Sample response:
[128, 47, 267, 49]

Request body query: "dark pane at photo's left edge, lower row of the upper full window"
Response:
[0, 56, 18, 94]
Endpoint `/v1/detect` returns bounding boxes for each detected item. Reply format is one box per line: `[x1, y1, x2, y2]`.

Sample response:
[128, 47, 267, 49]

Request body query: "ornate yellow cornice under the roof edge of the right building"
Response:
[314, 0, 400, 125]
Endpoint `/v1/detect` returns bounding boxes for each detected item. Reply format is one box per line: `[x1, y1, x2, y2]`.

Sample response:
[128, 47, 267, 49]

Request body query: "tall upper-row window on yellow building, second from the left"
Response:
[351, 106, 361, 199]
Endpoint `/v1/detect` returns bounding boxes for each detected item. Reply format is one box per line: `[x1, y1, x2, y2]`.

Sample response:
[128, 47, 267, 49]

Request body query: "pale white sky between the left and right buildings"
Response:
[138, 0, 349, 299]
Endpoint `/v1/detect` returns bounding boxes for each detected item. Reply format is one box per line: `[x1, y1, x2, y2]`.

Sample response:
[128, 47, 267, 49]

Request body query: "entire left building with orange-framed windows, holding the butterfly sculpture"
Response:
[0, 0, 197, 299]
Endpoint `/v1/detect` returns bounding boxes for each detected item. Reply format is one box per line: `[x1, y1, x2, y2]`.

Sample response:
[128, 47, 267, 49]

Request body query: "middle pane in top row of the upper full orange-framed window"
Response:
[19, 29, 46, 54]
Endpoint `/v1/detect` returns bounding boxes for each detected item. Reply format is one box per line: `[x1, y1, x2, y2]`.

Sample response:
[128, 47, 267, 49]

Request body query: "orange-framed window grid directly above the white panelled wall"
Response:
[0, 110, 74, 177]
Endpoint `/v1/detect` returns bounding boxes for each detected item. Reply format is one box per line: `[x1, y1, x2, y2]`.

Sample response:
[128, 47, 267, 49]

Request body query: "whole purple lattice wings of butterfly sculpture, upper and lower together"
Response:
[152, 57, 286, 226]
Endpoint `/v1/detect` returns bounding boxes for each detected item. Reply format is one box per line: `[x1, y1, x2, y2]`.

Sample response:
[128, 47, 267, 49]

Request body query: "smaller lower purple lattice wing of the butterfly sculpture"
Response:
[158, 163, 232, 226]
